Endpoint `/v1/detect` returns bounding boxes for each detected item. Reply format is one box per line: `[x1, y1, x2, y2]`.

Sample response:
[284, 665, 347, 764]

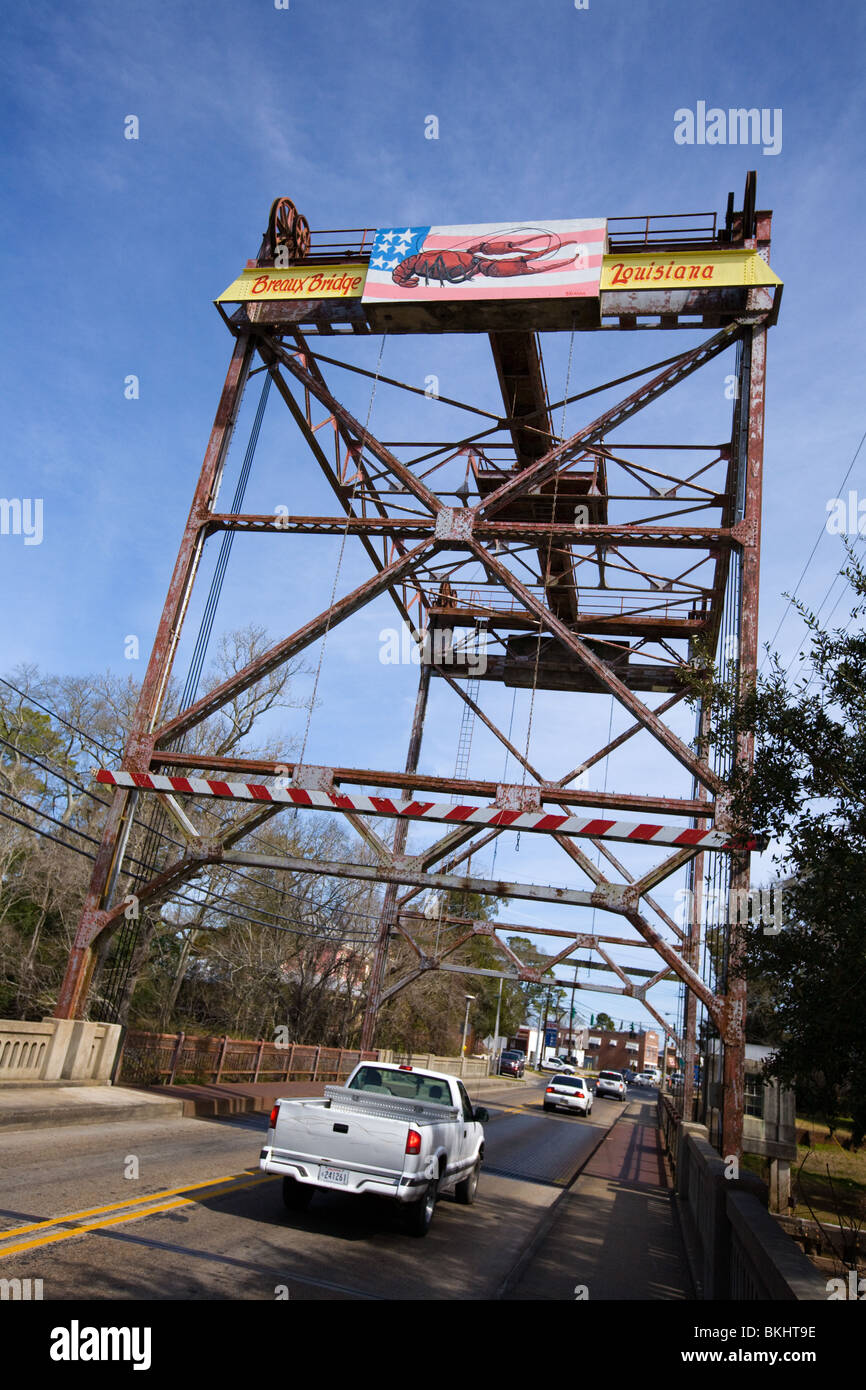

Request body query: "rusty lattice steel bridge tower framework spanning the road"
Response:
[57, 185, 778, 1154]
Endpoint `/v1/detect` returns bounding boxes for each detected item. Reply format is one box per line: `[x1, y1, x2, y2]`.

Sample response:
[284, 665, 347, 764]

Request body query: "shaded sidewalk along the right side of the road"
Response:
[505, 1101, 695, 1307]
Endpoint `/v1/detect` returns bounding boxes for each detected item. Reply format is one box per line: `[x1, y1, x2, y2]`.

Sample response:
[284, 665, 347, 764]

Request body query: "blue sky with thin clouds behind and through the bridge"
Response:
[0, 0, 866, 1039]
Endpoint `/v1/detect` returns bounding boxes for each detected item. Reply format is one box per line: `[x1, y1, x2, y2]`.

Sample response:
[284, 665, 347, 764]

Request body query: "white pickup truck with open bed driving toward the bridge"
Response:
[259, 1062, 489, 1236]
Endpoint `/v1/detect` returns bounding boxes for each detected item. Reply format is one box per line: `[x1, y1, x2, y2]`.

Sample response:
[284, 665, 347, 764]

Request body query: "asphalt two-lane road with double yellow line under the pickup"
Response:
[0, 1081, 623, 1300]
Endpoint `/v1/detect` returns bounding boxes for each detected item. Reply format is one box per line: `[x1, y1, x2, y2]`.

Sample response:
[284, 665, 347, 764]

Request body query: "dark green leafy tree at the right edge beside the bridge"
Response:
[702, 550, 866, 1144]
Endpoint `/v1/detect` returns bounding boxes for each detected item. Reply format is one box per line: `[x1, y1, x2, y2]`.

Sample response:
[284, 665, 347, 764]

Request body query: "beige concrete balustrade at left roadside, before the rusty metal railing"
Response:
[0, 1019, 121, 1084]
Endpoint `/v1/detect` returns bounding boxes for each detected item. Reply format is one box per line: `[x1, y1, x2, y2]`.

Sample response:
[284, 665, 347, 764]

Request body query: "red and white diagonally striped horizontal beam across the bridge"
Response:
[95, 767, 766, 851]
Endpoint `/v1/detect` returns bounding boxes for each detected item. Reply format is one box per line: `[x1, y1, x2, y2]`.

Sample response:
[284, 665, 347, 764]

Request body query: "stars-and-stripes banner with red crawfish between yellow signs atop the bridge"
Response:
[364, 218, 607, 304]
